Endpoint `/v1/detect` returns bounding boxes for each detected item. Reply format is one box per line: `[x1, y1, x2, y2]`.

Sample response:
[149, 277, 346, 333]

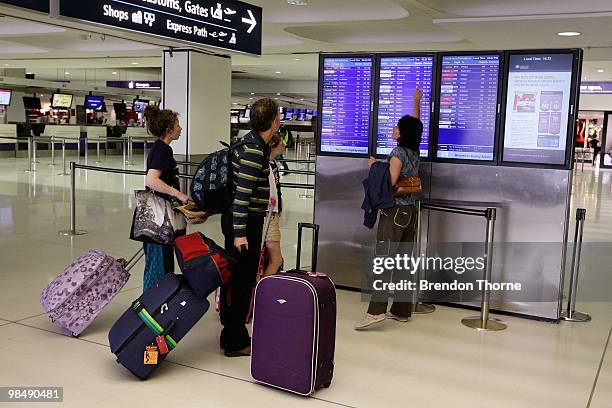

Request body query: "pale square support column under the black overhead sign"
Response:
[162, 50, 232, 159]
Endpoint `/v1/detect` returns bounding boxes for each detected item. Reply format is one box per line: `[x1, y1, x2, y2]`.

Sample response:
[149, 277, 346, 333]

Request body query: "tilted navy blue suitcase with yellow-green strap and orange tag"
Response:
[108, 274, 210, 380]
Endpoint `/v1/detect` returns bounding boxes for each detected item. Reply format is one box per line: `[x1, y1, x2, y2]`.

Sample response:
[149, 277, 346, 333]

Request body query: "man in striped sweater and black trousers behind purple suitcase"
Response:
[220, 98, 280, 357]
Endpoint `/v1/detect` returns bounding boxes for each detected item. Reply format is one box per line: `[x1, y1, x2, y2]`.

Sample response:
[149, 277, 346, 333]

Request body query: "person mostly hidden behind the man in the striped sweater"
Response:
[264, 132, 285, 276]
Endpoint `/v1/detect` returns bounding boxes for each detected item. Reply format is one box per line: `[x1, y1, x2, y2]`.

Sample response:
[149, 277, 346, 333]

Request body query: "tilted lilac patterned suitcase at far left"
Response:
[40, 249, 144, 337]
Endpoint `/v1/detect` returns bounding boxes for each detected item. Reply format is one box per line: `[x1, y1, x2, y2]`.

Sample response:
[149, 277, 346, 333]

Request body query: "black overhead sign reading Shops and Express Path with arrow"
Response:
[58, 0, 262, 55]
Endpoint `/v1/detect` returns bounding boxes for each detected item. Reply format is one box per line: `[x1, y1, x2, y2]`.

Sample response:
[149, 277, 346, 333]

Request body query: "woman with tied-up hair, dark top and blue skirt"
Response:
[143, 106, 189, 291]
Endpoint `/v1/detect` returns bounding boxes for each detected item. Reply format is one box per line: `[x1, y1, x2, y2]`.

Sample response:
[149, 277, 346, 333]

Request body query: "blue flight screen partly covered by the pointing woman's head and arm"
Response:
[376, 56, 434, 157]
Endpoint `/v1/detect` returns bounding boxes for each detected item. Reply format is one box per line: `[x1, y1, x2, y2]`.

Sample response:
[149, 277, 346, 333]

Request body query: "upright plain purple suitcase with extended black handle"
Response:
[251, 223, 336, 396]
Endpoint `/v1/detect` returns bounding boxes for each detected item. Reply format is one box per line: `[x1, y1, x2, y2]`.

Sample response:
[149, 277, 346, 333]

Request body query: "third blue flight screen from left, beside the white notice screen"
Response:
[437, 54, 500, 161]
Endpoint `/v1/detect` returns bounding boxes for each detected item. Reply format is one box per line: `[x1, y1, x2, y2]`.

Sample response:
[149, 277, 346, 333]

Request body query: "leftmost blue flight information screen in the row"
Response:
[320, 56, 373, 156]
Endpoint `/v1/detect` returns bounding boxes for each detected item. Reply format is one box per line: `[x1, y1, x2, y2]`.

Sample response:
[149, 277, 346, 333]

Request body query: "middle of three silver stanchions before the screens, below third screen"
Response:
[461, 208, 508, 331]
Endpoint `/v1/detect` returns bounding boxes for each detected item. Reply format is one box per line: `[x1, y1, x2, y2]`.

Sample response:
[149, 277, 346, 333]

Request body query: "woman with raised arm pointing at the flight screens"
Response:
[355, 87, 423, 330]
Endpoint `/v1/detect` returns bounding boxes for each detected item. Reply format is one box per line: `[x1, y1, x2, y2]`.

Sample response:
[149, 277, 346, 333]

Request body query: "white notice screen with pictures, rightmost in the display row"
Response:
[503, 54, 574, 165]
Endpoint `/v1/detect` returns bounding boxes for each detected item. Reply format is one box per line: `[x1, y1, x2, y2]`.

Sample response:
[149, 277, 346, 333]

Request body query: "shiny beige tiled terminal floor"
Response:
[0, 151, 612, 408]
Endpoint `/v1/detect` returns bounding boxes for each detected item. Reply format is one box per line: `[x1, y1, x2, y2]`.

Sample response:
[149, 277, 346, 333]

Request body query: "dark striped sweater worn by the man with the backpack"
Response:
[232, 131, 270, 238]
